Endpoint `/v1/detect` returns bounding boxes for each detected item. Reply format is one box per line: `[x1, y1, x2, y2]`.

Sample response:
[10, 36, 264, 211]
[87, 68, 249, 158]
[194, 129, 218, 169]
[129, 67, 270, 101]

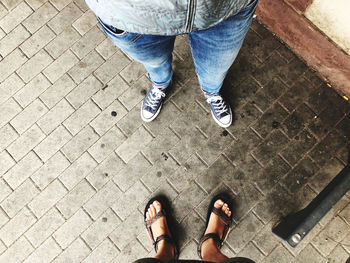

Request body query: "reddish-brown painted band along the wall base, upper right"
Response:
[257, 0, 350, 98]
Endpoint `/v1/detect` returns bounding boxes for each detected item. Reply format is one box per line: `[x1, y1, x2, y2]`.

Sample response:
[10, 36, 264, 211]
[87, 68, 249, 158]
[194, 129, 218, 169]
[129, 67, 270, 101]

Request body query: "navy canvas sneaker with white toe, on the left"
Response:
[141, 86, 166, 122]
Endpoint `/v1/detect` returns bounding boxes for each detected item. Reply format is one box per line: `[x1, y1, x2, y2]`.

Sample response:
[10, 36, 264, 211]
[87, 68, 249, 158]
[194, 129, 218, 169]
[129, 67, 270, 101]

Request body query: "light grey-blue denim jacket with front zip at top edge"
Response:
[85, 0, 254, 35]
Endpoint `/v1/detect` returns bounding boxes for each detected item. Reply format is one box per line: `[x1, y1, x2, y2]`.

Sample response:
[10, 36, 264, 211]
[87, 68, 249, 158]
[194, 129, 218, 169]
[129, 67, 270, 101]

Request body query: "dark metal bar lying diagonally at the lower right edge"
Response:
[272, 165, 350, 247]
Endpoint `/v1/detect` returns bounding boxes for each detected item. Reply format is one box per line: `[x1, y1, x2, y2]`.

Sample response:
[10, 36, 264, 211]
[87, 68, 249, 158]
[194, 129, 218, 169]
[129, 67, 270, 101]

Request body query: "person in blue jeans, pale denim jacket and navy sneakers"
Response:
[85, 0, 258, 127]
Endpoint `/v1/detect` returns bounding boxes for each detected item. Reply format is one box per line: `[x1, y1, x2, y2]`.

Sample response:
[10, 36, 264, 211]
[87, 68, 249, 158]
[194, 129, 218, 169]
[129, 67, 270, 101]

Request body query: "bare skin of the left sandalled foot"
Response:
[146, 201, 175, 261]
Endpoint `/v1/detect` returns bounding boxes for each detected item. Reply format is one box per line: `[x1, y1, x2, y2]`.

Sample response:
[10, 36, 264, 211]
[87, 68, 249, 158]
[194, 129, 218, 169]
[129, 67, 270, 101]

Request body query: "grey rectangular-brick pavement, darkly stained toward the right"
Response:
[0, 0, 350, 263]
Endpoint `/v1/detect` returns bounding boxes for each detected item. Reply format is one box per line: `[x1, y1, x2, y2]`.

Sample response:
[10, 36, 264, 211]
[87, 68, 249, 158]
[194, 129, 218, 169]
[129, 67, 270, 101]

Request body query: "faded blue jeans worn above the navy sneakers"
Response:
[99, 0, 258, 94]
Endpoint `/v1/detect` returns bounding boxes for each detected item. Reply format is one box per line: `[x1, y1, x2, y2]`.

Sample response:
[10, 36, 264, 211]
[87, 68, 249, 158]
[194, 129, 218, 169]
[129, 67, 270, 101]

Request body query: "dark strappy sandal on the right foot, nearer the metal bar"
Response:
[197, 194, 233, 259]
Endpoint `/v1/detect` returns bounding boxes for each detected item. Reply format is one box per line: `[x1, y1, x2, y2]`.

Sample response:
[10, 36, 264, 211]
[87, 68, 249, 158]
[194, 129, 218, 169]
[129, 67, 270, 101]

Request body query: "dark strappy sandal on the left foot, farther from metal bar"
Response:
[144, 197, 179, 259]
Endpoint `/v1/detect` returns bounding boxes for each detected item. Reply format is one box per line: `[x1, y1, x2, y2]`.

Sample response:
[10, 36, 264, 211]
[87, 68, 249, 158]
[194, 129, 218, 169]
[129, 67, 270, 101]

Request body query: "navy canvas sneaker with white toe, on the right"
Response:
[206, 94, 232, 128]
